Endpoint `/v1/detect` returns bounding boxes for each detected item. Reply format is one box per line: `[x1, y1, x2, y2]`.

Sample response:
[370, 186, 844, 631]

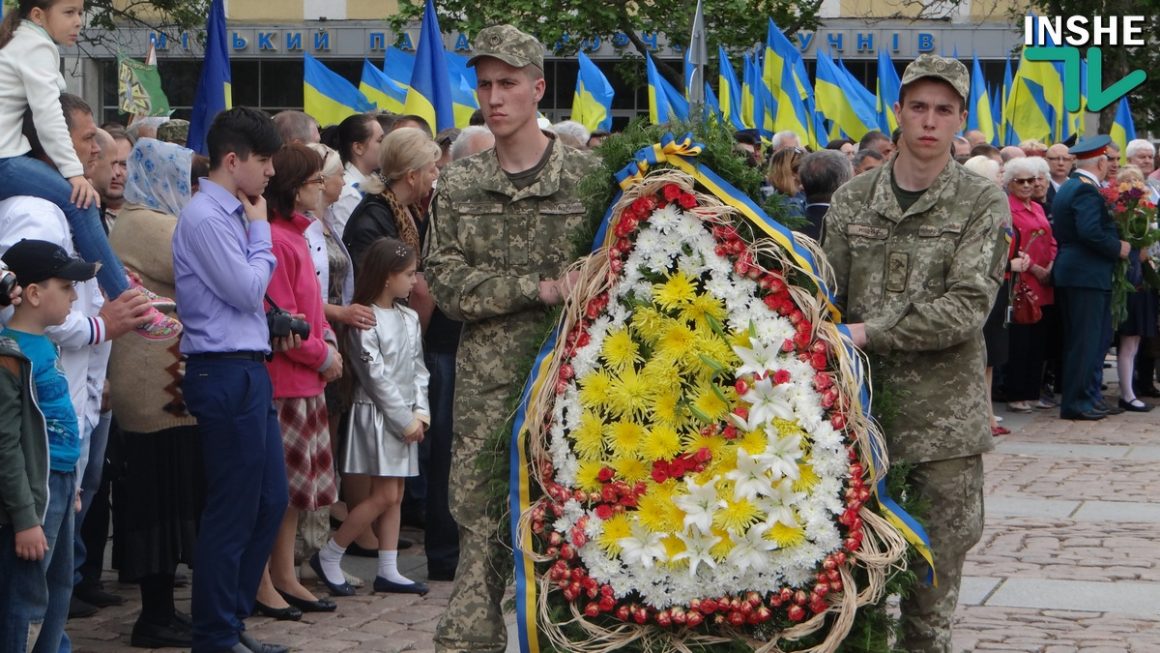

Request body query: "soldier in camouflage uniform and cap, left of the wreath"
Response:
[426, 26, 596, 653]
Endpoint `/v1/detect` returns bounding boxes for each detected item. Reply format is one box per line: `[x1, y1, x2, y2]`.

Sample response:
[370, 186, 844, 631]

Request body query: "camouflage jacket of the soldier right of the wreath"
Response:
[822, 161, 1010, 463]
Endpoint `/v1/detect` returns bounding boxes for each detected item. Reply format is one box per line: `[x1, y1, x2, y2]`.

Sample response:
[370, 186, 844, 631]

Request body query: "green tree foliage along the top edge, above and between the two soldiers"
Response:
[390, 0, 821, 88]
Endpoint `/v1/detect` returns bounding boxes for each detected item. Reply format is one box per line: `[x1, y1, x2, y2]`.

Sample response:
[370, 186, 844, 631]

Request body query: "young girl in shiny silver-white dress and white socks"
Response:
[310, 238, 430, 596]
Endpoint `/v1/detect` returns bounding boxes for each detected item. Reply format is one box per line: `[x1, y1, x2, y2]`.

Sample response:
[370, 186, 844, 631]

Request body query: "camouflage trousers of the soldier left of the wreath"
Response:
[435, 431, 513, 653]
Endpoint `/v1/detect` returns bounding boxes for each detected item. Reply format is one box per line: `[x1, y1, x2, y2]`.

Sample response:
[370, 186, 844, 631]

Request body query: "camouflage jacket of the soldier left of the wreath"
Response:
[425, 136, 599, 421]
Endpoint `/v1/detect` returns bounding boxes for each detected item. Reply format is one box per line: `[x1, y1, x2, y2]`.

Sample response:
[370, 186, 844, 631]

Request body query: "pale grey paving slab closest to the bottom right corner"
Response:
[985, 578, 1160, 617]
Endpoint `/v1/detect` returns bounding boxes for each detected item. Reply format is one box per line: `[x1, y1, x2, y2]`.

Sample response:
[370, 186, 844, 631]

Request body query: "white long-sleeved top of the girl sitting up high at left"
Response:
[0, 23, 85, 179]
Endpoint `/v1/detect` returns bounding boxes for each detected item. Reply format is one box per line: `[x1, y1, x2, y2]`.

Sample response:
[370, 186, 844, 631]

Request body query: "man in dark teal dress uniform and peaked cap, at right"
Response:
[1052, 135, 1130, 420]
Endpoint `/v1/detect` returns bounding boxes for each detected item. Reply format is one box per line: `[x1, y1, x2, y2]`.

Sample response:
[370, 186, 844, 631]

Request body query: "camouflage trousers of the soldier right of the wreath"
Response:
[898, 455, 983, 653]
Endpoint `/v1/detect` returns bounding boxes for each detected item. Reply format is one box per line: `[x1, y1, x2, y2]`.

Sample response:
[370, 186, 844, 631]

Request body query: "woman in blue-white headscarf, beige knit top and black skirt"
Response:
[108, 138, 204, 647]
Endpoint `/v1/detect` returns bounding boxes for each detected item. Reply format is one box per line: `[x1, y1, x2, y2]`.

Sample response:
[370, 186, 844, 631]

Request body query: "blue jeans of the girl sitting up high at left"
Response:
[0, 154, 129, 299]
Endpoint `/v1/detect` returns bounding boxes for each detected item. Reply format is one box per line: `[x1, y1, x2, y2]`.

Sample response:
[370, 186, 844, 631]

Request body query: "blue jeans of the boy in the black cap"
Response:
[0, 472, 77, 653]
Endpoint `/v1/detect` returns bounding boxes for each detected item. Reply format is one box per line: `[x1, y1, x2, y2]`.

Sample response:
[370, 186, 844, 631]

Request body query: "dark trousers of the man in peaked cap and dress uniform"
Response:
[1056, 286, 1111, 419]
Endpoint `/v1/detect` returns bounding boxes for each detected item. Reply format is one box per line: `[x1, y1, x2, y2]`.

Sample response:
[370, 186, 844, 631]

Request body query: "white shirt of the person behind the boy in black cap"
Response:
[0, 195, 111, 438]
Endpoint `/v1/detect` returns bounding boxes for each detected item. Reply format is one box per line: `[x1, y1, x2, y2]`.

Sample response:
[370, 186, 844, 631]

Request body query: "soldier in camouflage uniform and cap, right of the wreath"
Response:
[822, 55, 1010, 652]
